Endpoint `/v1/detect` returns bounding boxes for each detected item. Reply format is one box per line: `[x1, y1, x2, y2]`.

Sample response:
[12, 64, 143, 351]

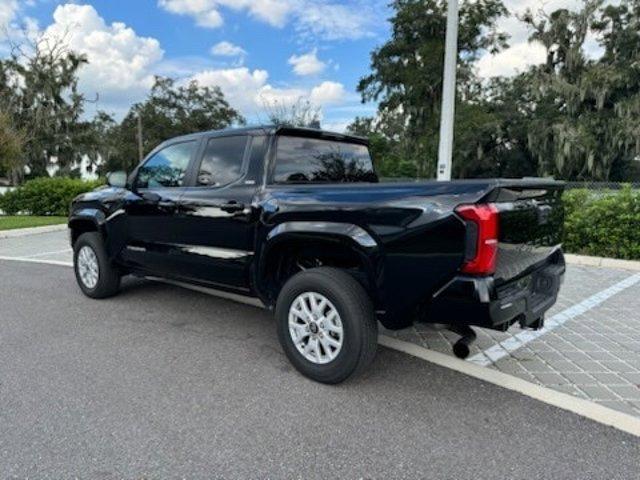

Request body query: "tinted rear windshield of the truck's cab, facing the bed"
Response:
[273, 135, 377, 183]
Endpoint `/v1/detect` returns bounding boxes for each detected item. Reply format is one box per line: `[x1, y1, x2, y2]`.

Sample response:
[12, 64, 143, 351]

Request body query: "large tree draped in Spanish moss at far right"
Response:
[504, 0, 640, 180]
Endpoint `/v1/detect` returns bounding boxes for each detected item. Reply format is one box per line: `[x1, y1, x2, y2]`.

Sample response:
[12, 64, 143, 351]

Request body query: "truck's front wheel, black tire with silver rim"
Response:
[73, 232, 120, 298]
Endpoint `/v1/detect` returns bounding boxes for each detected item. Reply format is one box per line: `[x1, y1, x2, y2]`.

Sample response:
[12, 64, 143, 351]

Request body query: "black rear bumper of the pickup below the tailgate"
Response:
[425, 251, 565, 330]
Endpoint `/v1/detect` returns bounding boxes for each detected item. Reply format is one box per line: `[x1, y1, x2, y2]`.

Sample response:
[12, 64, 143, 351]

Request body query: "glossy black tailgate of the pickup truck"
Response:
[486, 180, 564, 285]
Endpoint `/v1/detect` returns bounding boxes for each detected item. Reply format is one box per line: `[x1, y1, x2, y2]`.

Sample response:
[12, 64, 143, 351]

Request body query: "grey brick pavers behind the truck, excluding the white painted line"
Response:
[385, 265, 640, 416]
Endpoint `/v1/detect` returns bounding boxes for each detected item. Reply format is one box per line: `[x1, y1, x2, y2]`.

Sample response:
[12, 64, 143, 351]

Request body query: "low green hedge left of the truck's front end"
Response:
[0, 177, 103, 216]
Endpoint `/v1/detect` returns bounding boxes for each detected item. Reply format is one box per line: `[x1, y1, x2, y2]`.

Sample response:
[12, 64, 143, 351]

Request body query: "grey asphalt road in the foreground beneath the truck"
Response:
[0, 261, 640, 479]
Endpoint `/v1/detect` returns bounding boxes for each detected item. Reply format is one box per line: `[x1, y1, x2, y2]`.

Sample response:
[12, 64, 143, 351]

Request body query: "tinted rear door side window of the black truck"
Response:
[197, 136, 249, 187]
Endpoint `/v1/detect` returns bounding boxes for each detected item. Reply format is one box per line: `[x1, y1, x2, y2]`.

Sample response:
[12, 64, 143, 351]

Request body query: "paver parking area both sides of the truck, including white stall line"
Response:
[0, 231, 640, 417]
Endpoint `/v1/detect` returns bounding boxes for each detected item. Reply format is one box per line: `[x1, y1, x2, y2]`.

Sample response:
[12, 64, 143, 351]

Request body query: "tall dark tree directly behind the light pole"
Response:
[358, 0, 507, 176]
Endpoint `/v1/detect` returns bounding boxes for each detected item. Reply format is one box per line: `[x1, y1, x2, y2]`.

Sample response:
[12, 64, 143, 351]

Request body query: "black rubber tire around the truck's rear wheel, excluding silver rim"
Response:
[275, 267, 378, 384]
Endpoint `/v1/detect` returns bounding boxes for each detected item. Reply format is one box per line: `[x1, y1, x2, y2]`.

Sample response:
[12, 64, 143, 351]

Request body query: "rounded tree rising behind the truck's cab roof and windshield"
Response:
[101, 77, 244, 174]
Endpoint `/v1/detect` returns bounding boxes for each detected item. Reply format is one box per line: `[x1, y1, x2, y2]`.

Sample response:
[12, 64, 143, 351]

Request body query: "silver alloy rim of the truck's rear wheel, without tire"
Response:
[289, 292, 344, 365]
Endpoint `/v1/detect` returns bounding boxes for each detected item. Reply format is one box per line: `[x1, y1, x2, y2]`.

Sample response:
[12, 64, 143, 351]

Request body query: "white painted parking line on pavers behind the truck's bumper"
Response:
[467, 273, 640, 367]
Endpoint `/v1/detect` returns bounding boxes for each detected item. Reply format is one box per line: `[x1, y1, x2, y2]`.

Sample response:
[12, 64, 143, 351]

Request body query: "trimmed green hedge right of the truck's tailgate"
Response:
[563, 186, 640, 260]
